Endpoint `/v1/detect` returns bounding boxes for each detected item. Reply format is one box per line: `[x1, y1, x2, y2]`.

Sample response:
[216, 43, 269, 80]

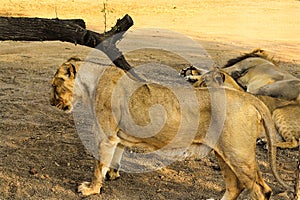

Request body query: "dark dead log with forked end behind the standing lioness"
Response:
[0, 15, 143, 80]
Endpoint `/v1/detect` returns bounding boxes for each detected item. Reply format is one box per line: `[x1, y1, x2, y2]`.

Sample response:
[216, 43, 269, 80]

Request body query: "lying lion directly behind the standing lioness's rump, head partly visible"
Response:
[180, 65, 300, 148]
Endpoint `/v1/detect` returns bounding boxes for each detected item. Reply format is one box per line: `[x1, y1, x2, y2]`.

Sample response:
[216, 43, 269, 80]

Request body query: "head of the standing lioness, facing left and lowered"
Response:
[50, 60, 77, 112]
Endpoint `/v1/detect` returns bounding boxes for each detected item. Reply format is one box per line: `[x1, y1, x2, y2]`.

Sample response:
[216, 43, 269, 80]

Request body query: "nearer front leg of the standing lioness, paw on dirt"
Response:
[78, 136, 119, 196]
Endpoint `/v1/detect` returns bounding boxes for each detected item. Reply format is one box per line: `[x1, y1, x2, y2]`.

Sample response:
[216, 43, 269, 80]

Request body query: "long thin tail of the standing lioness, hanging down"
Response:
[254, 101, 293, 191]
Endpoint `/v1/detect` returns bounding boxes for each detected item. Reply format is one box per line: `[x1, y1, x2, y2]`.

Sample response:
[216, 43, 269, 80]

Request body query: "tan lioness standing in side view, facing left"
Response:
[50, 59, 290, 200]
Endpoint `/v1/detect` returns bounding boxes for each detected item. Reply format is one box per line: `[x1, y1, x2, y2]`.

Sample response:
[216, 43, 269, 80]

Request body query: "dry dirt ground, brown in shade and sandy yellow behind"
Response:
[0, 0, 300, 200]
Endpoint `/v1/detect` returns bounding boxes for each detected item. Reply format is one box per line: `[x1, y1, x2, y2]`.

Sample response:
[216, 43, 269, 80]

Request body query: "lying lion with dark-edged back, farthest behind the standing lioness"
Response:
[222, 49, 300, 101]
